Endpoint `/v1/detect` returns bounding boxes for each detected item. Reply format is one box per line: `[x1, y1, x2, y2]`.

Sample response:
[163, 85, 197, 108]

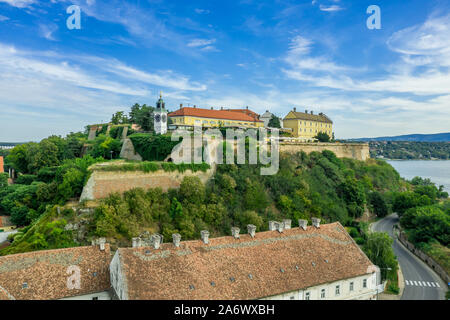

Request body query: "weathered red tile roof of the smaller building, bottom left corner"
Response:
[0, 244, 111, 300]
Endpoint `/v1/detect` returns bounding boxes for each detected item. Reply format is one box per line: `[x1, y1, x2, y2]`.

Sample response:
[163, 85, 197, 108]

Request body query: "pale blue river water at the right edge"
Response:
[387, 160, 450, 193]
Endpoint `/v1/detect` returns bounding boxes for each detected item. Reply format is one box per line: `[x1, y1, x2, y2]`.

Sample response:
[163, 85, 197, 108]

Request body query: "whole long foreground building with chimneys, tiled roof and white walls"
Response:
[110, 218, 380, 300]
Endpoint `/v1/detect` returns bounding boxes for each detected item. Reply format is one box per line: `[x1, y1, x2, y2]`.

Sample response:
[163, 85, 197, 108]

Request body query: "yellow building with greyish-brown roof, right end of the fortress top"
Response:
[283, 108, 333, 139]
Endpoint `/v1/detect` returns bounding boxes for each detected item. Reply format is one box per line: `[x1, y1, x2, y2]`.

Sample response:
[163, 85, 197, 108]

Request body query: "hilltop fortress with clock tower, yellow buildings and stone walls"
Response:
[80, 95, 370, 201]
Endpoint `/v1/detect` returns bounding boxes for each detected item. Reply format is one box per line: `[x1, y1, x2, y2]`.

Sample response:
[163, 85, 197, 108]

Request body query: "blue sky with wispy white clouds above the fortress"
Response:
[0, 0, 450, 141]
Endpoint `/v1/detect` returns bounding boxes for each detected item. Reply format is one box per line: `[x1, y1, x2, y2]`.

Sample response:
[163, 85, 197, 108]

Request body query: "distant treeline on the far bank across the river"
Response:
[369, 141, 450, 160]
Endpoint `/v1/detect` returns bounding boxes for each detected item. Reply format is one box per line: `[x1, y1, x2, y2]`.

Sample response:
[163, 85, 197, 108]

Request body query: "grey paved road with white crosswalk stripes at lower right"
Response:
[372, 214, 447, 300]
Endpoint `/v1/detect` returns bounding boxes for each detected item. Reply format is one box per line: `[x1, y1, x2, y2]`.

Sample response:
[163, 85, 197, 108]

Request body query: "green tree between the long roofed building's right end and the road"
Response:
[362, 232, 398, 280]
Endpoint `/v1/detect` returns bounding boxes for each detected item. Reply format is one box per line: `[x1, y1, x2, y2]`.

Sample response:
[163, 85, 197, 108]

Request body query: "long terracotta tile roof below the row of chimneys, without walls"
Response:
[119, 223, 372, 300]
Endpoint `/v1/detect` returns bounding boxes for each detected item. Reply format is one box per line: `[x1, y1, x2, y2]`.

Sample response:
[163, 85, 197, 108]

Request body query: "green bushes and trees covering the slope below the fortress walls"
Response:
[0, 151, 408, 254]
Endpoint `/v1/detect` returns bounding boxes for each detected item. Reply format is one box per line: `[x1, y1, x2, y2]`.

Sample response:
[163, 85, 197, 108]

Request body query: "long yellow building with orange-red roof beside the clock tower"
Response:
[168, 107, 264, 128]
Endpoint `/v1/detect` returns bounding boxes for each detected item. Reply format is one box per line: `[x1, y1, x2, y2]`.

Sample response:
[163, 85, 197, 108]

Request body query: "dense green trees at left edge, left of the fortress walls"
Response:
[0, 133, 103, 226]
